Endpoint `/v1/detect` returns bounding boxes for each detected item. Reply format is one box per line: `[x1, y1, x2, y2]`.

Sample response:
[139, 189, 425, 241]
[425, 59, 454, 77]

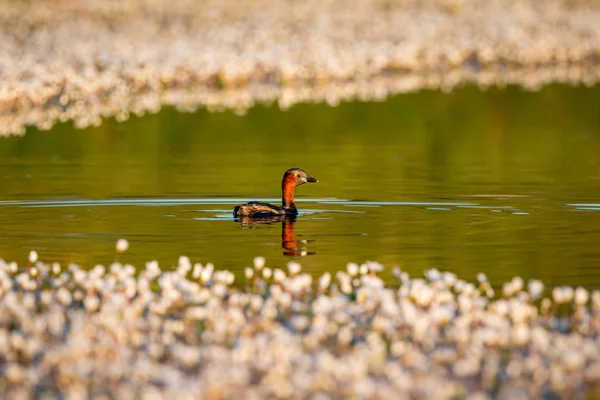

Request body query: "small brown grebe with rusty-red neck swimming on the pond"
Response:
[233, 168, 318, 218]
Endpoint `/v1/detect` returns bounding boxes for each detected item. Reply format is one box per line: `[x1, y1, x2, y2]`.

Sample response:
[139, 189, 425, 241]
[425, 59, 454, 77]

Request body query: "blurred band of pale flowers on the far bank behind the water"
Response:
[0, 0, 600, 135]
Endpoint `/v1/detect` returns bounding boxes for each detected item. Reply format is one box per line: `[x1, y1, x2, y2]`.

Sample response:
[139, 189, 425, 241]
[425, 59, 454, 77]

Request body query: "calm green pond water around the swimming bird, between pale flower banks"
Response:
[0, 86, 600, 287]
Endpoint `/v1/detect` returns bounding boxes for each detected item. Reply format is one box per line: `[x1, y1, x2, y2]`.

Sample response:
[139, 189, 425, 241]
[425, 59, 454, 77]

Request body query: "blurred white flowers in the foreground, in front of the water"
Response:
[0, 252, 600, 399]
